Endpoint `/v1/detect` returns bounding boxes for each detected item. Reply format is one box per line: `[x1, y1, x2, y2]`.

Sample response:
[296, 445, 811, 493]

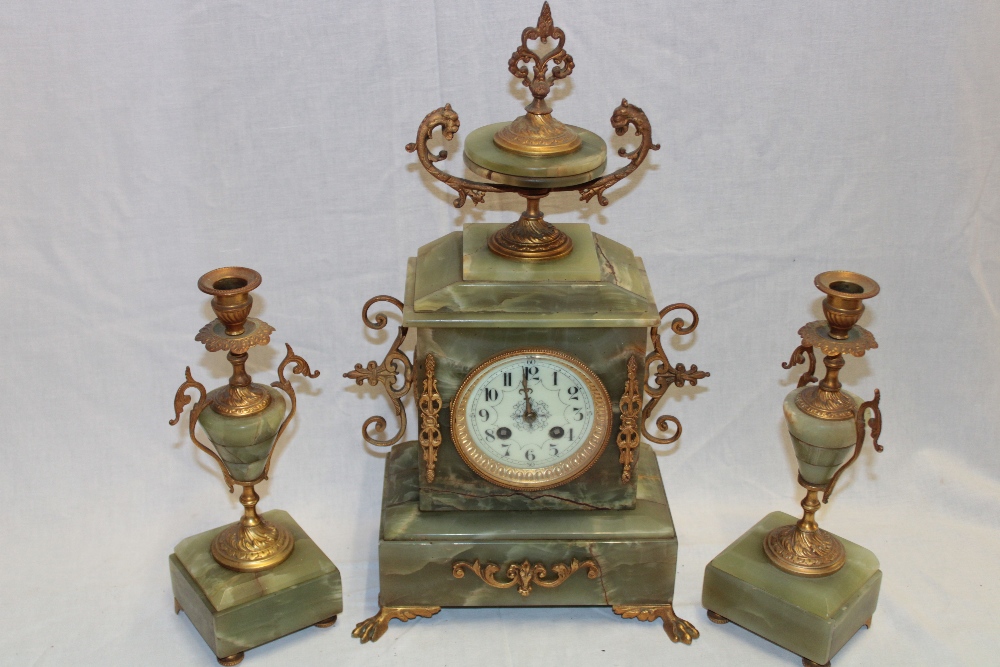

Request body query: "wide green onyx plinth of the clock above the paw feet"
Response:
[379, 442, 677, 607]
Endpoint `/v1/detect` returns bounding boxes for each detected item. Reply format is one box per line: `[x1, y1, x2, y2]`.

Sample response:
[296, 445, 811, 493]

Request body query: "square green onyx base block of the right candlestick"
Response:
[702, 512, 882, 665]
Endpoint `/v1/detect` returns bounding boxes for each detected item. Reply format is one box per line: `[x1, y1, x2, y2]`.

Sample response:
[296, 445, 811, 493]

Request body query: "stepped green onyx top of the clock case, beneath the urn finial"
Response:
[403, 224, 660, 328]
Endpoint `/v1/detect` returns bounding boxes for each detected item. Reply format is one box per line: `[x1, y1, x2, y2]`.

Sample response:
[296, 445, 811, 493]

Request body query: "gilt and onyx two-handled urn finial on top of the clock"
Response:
[406, 2, 660, 260]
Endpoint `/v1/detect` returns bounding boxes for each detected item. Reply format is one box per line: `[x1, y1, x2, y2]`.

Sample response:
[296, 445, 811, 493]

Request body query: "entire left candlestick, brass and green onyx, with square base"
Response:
[170, 267, 343, 665]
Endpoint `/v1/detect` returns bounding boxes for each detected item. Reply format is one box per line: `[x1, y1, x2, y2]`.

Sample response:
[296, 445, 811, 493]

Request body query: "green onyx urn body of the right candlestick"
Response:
[783, 387, 861, 486]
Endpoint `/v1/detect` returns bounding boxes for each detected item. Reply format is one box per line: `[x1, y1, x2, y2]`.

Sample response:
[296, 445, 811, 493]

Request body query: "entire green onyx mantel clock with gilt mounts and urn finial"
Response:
[345, 4, 708, 643]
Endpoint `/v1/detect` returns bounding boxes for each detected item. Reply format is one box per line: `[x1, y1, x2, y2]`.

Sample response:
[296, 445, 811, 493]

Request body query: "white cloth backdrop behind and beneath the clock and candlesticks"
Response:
[0, 0, 1000, 666]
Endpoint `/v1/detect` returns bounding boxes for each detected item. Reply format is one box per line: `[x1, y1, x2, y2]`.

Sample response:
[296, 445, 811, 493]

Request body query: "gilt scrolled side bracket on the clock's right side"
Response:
[642, 303, 711, 445]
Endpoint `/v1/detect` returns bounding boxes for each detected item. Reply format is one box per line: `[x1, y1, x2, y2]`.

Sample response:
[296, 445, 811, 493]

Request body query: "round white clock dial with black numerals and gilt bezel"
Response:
[452, 349, 611, 489]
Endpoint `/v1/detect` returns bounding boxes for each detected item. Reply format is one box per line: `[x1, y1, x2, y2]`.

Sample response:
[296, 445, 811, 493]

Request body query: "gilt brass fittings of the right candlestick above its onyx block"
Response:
[764, 271, 882, 577]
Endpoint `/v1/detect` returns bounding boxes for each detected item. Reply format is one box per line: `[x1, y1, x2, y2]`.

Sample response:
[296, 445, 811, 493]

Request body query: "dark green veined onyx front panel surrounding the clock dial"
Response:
[414, 327, 648, 511]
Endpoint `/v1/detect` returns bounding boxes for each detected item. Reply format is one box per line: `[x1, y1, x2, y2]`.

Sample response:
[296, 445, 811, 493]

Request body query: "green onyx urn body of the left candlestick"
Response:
[198, 387, 285, 482]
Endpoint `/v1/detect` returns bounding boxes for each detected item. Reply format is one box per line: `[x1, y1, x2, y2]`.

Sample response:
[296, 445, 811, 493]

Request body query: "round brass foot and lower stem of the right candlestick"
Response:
[764, 475, 847, 577]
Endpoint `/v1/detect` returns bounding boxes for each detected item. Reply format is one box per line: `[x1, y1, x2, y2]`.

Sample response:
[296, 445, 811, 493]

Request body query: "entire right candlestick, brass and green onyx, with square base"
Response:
[702, 271, 882, 666]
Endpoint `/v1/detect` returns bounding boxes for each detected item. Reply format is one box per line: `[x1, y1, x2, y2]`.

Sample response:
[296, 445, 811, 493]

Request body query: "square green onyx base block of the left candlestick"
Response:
[170, 510, 344, 659]
